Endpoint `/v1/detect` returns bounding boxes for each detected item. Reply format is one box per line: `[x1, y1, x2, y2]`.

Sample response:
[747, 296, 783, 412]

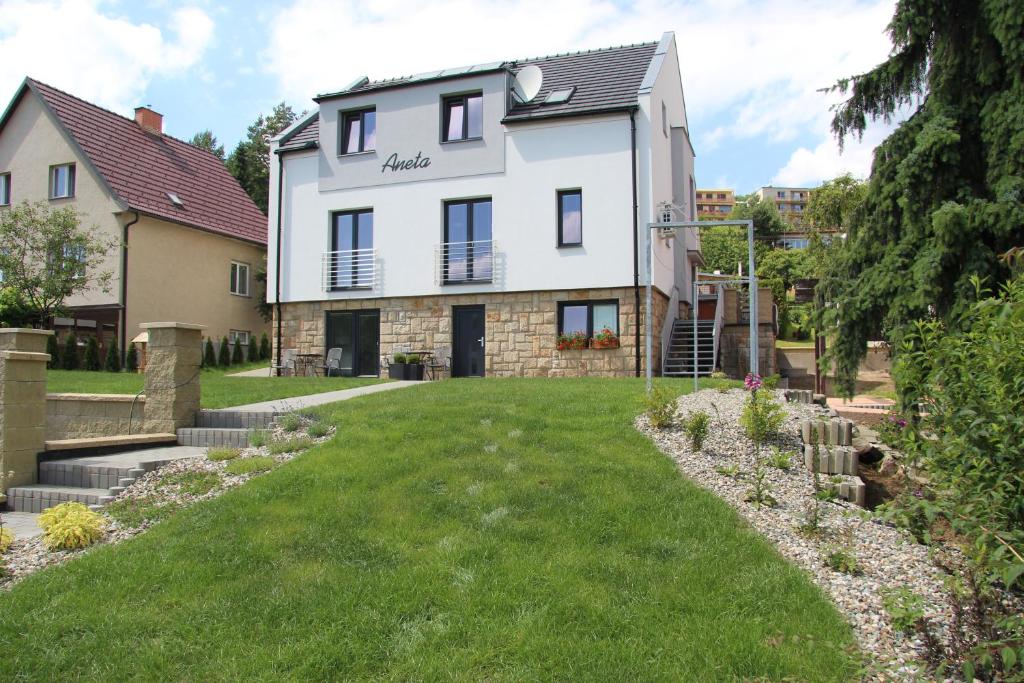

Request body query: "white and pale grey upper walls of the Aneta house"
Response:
[267, 34, 698, 309]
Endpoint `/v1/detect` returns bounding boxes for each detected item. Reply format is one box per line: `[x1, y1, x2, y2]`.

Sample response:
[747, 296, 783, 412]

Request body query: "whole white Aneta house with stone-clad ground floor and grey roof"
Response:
[267, 33, 699, 376]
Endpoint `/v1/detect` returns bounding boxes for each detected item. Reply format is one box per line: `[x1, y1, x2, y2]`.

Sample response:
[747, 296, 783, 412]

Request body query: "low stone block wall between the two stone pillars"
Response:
[46, 393, 145, 441]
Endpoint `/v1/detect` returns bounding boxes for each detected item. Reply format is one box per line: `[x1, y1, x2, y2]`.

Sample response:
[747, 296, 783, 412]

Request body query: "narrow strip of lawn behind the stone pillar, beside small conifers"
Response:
[46, 364, 381, 408]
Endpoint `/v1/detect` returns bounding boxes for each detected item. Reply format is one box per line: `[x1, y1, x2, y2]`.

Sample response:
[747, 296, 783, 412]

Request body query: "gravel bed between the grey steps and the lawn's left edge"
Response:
[0, 419, 335, 590]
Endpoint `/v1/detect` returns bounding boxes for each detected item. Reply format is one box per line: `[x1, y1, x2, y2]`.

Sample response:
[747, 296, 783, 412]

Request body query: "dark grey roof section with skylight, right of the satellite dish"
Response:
[504, 43, 657, 122]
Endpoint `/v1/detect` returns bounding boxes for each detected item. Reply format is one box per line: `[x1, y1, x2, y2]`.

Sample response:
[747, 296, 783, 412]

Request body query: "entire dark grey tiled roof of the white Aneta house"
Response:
[307, 34, 659, 126]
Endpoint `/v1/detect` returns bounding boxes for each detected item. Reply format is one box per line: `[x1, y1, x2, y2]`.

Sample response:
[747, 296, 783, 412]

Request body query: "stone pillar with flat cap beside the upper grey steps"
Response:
[139, 323, 205, 434]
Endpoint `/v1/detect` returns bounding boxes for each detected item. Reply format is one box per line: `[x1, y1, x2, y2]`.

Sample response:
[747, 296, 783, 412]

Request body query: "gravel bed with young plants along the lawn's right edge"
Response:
[637, 389, 950, 680]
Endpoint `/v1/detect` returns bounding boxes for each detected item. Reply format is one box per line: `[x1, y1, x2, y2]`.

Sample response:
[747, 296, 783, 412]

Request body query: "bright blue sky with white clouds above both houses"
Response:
[0, 0, 894, 193]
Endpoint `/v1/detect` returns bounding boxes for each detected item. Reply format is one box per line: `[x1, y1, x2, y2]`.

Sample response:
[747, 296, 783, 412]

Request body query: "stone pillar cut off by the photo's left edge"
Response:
[0, 328, 53, 491]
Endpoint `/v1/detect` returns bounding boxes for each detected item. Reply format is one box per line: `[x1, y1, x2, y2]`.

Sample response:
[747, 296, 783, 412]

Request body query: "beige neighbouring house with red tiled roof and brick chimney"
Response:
[0, 79, 268, 352]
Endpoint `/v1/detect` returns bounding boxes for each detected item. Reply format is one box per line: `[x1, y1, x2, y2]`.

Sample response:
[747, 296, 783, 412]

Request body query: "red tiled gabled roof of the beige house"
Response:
[0, 79, 267, 245]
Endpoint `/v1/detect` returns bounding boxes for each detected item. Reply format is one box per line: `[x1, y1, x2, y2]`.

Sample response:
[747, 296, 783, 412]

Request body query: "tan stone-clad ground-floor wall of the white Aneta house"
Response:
[274, 287, 669, 377]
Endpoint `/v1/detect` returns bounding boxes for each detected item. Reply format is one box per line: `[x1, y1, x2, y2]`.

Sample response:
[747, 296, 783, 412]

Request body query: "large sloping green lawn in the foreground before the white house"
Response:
[0, 379, 855, 681]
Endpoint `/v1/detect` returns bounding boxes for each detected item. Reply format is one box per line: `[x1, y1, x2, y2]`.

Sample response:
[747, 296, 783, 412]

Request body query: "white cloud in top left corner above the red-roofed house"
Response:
[0, 0, 214, 113]
